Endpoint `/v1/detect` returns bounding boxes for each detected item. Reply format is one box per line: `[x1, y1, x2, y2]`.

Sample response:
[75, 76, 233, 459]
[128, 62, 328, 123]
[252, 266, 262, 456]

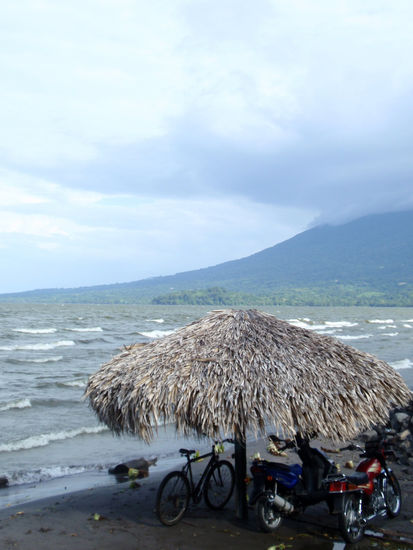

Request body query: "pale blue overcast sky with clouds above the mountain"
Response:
[0, 0, 413, 292]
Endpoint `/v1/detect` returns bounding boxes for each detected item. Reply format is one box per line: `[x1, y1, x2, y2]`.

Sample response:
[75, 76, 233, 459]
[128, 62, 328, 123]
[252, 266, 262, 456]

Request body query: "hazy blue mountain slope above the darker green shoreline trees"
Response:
[0, 211, 413, 305]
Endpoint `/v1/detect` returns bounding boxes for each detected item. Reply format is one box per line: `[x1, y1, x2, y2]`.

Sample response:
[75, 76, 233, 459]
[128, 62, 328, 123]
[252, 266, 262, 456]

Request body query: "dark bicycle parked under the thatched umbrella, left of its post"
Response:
[155, 439, 235, 526]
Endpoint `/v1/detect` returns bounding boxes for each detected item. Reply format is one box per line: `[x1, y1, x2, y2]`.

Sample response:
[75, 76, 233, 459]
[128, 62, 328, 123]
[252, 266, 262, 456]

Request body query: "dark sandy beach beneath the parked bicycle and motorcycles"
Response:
[0, 441, 413, 550]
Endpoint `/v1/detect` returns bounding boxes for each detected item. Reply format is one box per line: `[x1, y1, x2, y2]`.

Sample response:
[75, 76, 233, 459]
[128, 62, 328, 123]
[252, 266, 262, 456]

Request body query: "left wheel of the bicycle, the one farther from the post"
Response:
[155, 472, 191, 526]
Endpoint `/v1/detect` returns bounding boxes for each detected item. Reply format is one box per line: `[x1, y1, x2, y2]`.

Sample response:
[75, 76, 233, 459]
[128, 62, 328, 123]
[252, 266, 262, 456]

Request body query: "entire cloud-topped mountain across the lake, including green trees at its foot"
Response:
[0, 212, 413, 306]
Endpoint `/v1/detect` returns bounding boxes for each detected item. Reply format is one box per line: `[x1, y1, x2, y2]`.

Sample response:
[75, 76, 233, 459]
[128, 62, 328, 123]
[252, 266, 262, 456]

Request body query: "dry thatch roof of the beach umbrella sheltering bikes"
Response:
[86, 310, 411, 441]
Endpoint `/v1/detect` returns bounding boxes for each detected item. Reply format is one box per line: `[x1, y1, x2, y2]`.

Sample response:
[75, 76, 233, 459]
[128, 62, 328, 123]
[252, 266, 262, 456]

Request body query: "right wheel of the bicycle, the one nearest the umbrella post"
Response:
[204, 460, 235, 510]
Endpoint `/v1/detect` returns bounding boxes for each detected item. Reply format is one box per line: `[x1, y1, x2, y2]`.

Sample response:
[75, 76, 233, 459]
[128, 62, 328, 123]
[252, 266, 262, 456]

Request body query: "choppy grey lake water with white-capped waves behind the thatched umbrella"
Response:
[0, 304, 413, 506]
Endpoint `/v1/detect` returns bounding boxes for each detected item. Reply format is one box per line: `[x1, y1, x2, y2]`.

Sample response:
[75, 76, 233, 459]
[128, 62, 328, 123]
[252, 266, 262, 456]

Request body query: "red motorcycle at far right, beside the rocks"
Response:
[329, 436, 402, 543]
